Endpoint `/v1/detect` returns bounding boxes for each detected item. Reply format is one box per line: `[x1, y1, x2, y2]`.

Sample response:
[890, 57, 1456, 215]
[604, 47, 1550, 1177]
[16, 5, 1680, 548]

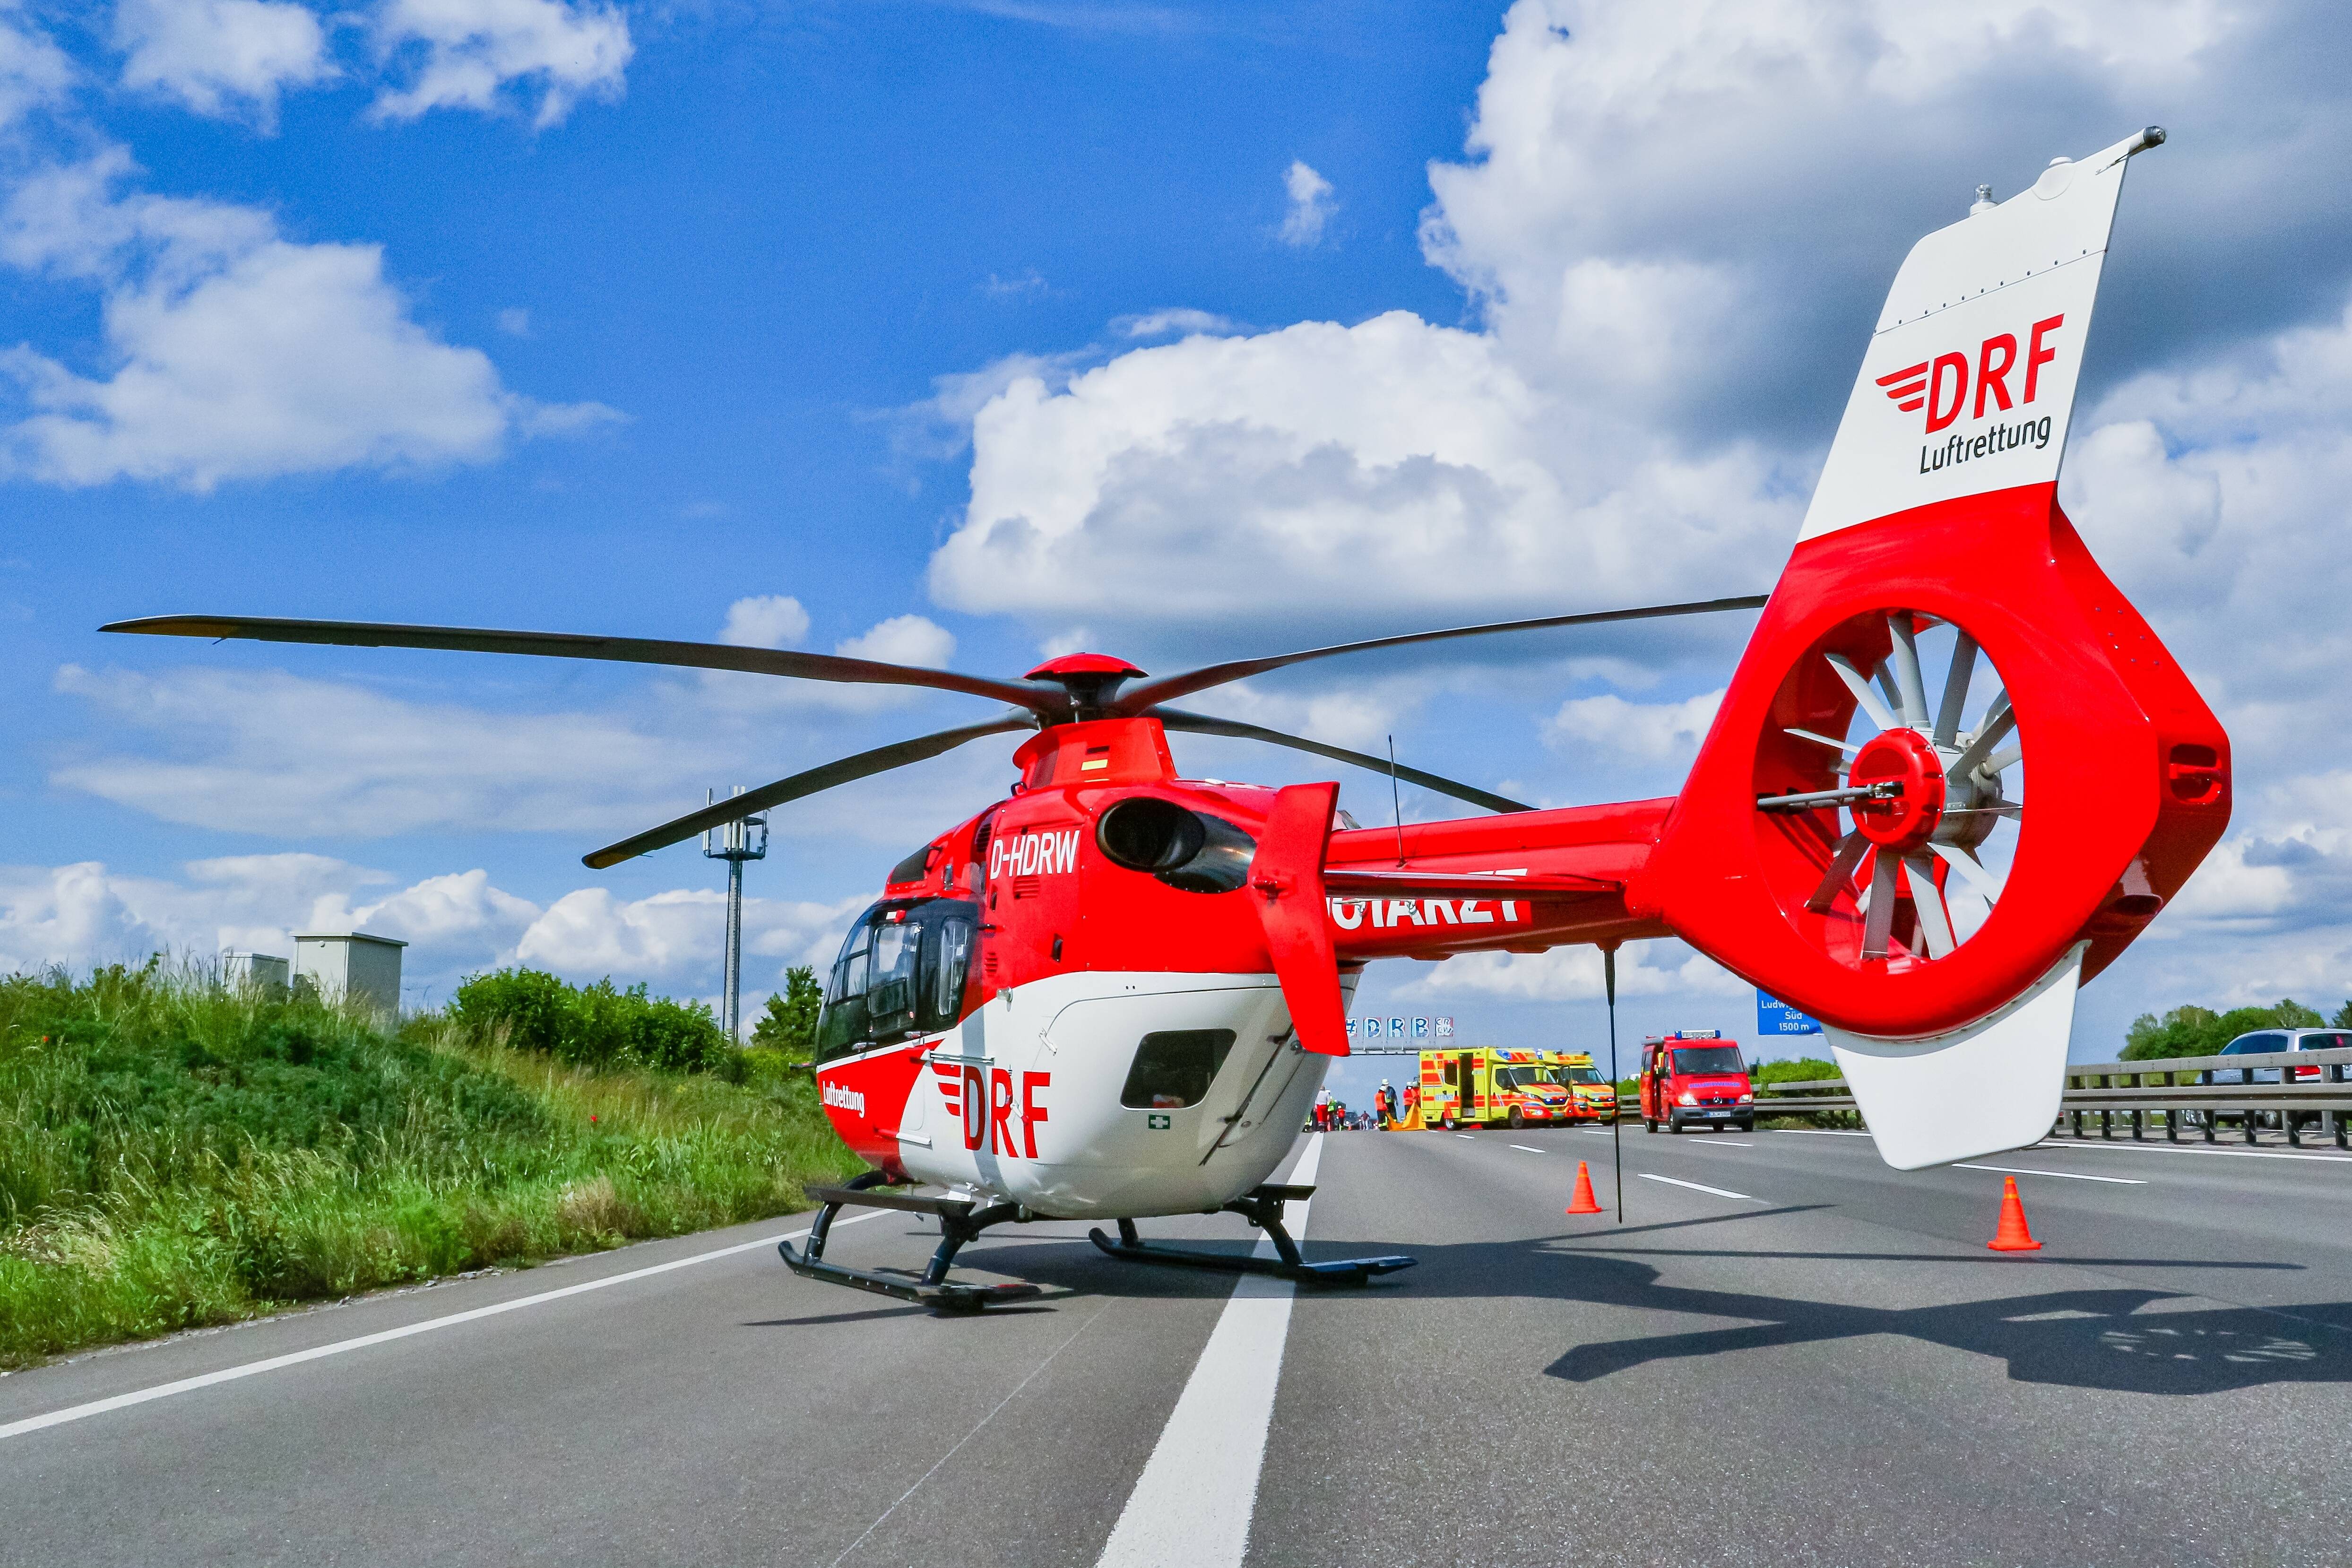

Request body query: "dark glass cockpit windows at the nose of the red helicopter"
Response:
[816, 898, 978, 1063]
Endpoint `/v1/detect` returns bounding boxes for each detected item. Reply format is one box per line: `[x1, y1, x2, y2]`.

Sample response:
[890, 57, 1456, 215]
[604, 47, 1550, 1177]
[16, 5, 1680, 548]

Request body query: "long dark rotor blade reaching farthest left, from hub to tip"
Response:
[99, 616, 1070, 715]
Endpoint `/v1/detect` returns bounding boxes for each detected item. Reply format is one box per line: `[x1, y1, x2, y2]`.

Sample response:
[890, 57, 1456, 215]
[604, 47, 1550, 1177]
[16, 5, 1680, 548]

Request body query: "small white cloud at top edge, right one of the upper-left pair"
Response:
[369, 0, 635, 127]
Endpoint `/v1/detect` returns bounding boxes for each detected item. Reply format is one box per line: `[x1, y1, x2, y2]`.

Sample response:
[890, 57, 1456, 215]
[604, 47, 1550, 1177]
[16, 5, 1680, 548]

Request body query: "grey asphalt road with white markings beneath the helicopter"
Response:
[0, 1128, 2352, 1568]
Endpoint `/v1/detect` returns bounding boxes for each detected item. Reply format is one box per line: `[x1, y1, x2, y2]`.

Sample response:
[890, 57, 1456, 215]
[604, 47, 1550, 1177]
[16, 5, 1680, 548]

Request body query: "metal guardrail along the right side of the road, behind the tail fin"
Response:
[1757, 1051, 2352, 1150]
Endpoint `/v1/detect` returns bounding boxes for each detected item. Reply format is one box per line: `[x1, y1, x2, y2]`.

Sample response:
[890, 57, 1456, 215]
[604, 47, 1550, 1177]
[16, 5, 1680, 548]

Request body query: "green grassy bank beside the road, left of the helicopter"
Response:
[0, 964, 861, 1366]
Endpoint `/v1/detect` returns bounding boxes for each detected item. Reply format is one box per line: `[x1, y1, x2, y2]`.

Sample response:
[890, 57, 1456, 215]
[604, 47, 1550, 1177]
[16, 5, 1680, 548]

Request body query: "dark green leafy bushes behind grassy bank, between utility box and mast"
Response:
[449, 969, 743, 1082]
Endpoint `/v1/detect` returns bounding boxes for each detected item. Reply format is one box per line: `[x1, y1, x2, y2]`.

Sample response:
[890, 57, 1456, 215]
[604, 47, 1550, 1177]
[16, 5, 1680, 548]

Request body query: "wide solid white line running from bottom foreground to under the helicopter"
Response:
[1096, 1133, 1322, 1568]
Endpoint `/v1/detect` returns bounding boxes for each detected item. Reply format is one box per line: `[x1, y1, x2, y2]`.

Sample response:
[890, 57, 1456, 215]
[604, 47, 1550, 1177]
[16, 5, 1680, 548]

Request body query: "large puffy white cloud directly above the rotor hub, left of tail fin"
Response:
[931, 310, 1799, 625]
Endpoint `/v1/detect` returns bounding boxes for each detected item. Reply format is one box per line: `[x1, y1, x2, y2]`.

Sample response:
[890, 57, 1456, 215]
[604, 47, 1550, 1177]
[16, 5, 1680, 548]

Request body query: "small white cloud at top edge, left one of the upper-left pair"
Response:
[115, 0, 337, 125]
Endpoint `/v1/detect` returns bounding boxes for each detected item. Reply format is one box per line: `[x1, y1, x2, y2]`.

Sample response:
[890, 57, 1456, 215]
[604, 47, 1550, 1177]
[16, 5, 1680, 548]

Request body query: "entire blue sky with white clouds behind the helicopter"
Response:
[0, 0, 2352, 1100]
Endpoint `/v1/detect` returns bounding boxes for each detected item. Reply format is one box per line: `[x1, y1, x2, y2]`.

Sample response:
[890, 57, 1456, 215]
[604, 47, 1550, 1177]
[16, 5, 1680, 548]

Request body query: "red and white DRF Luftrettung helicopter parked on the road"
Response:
[106, 127, 2230, 1309]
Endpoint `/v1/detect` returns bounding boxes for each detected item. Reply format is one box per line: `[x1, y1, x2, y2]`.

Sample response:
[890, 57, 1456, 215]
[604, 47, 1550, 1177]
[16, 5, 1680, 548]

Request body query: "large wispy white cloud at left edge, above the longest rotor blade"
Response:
[0, 148, 612, 491]
